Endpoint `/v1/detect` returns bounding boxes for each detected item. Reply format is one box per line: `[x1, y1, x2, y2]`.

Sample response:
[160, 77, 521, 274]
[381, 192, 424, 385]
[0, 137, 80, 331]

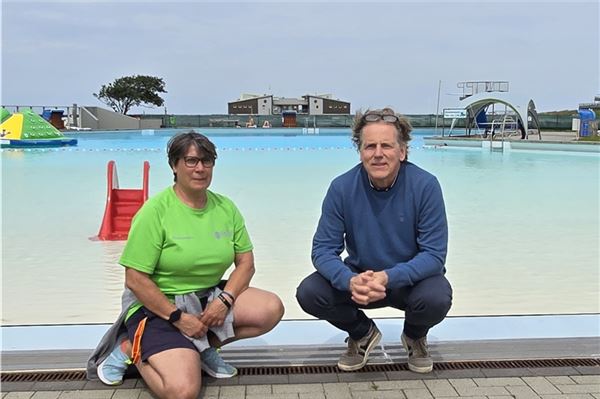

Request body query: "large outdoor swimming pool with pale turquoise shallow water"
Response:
[1, 129, 600, 325]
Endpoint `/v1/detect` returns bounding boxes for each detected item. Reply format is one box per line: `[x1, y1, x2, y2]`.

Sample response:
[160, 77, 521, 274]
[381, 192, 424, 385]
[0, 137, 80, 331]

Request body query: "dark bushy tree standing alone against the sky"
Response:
[93, 75, 167, 115]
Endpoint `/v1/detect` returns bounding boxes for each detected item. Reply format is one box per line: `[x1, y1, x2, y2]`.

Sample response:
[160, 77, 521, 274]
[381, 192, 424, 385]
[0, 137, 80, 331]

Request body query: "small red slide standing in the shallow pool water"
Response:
[97, 161, 150, 241]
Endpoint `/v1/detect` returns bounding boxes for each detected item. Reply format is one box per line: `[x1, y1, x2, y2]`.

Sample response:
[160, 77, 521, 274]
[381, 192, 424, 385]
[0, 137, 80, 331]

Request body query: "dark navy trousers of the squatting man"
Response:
[296, 272, 452, 340]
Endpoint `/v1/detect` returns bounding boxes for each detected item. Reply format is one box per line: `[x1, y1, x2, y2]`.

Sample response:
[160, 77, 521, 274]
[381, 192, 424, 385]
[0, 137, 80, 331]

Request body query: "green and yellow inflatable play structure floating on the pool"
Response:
[0, 108, 77, 148]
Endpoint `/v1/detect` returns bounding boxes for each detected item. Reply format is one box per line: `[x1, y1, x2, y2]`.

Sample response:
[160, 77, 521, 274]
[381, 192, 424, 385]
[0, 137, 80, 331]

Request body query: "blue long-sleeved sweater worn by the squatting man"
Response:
[312, 162, 448, 291]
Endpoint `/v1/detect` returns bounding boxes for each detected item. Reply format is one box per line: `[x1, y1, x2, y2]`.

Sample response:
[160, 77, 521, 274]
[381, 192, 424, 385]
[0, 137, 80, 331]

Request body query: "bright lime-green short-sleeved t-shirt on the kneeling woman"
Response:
[119, 187, 252, 316]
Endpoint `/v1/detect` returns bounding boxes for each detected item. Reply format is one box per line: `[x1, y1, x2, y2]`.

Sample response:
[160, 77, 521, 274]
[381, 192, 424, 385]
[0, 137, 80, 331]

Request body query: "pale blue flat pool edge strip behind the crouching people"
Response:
[0, 313, 600, 353]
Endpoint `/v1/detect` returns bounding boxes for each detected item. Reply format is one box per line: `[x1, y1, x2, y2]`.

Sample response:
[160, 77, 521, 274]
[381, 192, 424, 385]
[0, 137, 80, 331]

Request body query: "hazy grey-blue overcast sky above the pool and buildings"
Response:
[1, 0, 600, 114]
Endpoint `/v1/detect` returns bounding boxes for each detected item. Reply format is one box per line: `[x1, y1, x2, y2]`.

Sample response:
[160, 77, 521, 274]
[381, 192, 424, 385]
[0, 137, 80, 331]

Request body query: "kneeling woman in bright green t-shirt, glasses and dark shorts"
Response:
[88, 131, 284, 398]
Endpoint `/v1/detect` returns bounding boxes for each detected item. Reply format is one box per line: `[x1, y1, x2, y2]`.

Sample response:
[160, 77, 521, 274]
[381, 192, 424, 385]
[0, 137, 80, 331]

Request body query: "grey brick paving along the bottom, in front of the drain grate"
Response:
[2, 376, 600, 399]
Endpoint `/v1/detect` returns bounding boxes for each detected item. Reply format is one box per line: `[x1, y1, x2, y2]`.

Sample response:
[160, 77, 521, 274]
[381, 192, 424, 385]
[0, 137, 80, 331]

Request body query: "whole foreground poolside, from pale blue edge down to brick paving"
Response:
[1, 314, 600, 399]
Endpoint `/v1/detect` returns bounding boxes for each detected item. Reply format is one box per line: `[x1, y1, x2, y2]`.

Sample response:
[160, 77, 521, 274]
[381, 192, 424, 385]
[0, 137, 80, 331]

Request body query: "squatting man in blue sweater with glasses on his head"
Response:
[296, 108, 452, 373]
